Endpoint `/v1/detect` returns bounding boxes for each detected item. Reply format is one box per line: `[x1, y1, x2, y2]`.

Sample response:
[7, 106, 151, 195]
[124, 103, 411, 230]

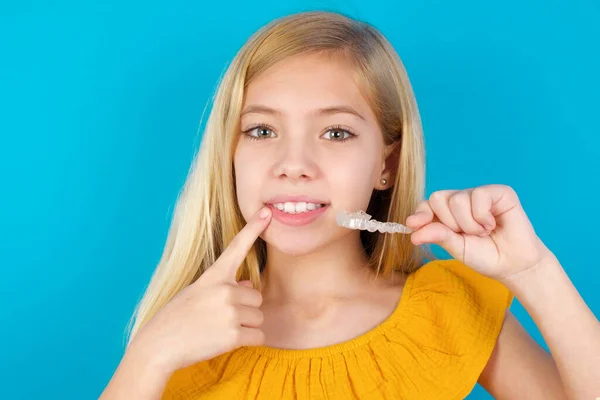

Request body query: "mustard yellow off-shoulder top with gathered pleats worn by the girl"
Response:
[163, 260, 513, 400]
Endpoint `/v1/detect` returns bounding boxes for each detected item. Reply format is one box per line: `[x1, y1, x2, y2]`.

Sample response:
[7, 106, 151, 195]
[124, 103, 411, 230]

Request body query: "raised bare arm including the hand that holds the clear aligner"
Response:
[406, 185, 600, 400]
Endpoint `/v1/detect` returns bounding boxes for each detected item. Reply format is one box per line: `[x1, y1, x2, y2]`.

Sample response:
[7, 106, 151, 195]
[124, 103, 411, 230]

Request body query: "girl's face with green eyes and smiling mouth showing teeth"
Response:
[234, 51, 391, 255]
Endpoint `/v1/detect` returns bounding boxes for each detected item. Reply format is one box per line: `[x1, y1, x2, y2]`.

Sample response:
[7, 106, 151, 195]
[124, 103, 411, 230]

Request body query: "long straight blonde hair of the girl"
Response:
[128, 11, 435, 343]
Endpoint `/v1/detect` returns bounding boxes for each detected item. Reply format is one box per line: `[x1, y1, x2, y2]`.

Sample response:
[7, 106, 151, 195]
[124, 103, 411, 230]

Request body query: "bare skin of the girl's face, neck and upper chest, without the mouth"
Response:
[234, 55, 402, 348]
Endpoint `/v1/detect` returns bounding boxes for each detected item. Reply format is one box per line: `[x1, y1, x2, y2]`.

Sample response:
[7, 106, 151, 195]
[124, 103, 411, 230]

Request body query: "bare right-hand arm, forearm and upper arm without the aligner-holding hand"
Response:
[480, 255, 600, 400]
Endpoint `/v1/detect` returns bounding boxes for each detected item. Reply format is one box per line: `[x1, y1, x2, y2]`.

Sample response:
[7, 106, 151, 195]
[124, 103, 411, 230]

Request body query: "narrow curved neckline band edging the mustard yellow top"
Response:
[238, 273, 415, 360]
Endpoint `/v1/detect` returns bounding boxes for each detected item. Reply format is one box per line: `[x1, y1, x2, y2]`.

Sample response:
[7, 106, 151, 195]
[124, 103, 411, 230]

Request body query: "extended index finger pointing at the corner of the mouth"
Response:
[214, 207, 271, 280]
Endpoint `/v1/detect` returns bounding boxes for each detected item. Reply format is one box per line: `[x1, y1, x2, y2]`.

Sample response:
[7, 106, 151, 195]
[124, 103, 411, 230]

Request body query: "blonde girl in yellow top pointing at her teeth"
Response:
[102, 12, 600, 400]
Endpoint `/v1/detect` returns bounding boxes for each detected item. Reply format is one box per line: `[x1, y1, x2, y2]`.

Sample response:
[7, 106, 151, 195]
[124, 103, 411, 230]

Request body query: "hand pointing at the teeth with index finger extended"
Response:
[132, 207, 271, 371]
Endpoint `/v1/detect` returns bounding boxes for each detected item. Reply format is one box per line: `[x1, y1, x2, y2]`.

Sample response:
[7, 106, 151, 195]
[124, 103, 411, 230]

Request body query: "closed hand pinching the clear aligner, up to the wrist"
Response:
[406, 185, 550, 281]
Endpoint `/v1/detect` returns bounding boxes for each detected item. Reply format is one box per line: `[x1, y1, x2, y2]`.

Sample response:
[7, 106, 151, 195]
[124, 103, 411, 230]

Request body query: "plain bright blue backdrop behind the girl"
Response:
[0, 0, 600, 399]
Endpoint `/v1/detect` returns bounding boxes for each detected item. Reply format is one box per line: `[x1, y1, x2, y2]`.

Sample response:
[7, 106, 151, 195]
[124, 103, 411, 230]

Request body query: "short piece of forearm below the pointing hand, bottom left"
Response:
[99, 345, 173, 400]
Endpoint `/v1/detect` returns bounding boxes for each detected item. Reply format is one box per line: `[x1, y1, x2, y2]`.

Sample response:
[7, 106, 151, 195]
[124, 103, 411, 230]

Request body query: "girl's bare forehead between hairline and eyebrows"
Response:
[244, 54, 371, 114]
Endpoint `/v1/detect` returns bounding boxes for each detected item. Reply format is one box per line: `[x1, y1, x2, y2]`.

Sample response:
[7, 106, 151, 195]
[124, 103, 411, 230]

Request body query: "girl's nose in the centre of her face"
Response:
[273, 139, 319, 183]
